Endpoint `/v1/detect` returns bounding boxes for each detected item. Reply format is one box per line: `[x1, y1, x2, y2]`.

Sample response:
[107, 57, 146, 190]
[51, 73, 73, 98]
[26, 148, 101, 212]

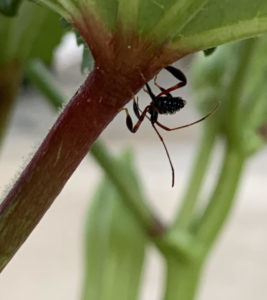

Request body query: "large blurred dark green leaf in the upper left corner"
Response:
[0, 2, 65, 64]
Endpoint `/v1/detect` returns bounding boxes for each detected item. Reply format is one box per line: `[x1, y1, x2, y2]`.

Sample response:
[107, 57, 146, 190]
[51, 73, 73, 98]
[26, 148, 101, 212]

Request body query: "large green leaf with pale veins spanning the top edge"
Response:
[38, 0, 267, 54]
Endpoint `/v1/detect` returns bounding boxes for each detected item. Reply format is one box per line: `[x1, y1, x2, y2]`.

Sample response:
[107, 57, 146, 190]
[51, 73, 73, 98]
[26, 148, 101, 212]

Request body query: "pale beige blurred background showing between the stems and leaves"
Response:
[0, 34, 267, 300]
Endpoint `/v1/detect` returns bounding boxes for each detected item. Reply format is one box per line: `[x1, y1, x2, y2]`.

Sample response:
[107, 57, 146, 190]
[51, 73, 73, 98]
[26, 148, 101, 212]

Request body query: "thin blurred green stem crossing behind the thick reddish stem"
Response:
[26, 59, 163, 236]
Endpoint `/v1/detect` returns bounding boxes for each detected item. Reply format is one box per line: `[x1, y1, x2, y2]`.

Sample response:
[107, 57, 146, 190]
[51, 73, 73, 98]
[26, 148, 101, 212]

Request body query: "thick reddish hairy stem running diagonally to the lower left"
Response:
[0, 69, 148, 270]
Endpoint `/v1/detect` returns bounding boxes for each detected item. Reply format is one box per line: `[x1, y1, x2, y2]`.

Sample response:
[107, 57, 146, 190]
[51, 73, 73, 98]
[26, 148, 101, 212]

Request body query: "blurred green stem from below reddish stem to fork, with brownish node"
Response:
[91, 141, 197, 261]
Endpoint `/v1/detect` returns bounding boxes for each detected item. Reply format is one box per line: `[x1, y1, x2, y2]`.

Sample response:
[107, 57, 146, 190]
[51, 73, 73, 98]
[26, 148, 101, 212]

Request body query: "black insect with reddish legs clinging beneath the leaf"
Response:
[123, 66, 218, 187]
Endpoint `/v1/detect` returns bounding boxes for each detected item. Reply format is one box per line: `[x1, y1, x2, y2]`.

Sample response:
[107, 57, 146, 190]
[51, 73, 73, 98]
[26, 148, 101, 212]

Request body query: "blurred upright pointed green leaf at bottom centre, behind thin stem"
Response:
[82, 154, 146, 300]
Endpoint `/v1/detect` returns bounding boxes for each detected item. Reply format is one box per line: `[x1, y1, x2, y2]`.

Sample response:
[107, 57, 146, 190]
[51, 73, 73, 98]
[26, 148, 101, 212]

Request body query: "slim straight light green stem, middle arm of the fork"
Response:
[173, 120, 217, 229]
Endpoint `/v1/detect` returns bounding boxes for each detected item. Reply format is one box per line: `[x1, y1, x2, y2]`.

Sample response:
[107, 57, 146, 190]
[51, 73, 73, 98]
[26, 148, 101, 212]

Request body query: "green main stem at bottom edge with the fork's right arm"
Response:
[164, 147, 245, 300]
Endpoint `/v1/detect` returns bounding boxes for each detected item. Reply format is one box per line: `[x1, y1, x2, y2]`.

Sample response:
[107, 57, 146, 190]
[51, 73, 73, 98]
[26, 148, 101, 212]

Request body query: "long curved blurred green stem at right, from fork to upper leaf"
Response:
[196, 40, 256, 253]
